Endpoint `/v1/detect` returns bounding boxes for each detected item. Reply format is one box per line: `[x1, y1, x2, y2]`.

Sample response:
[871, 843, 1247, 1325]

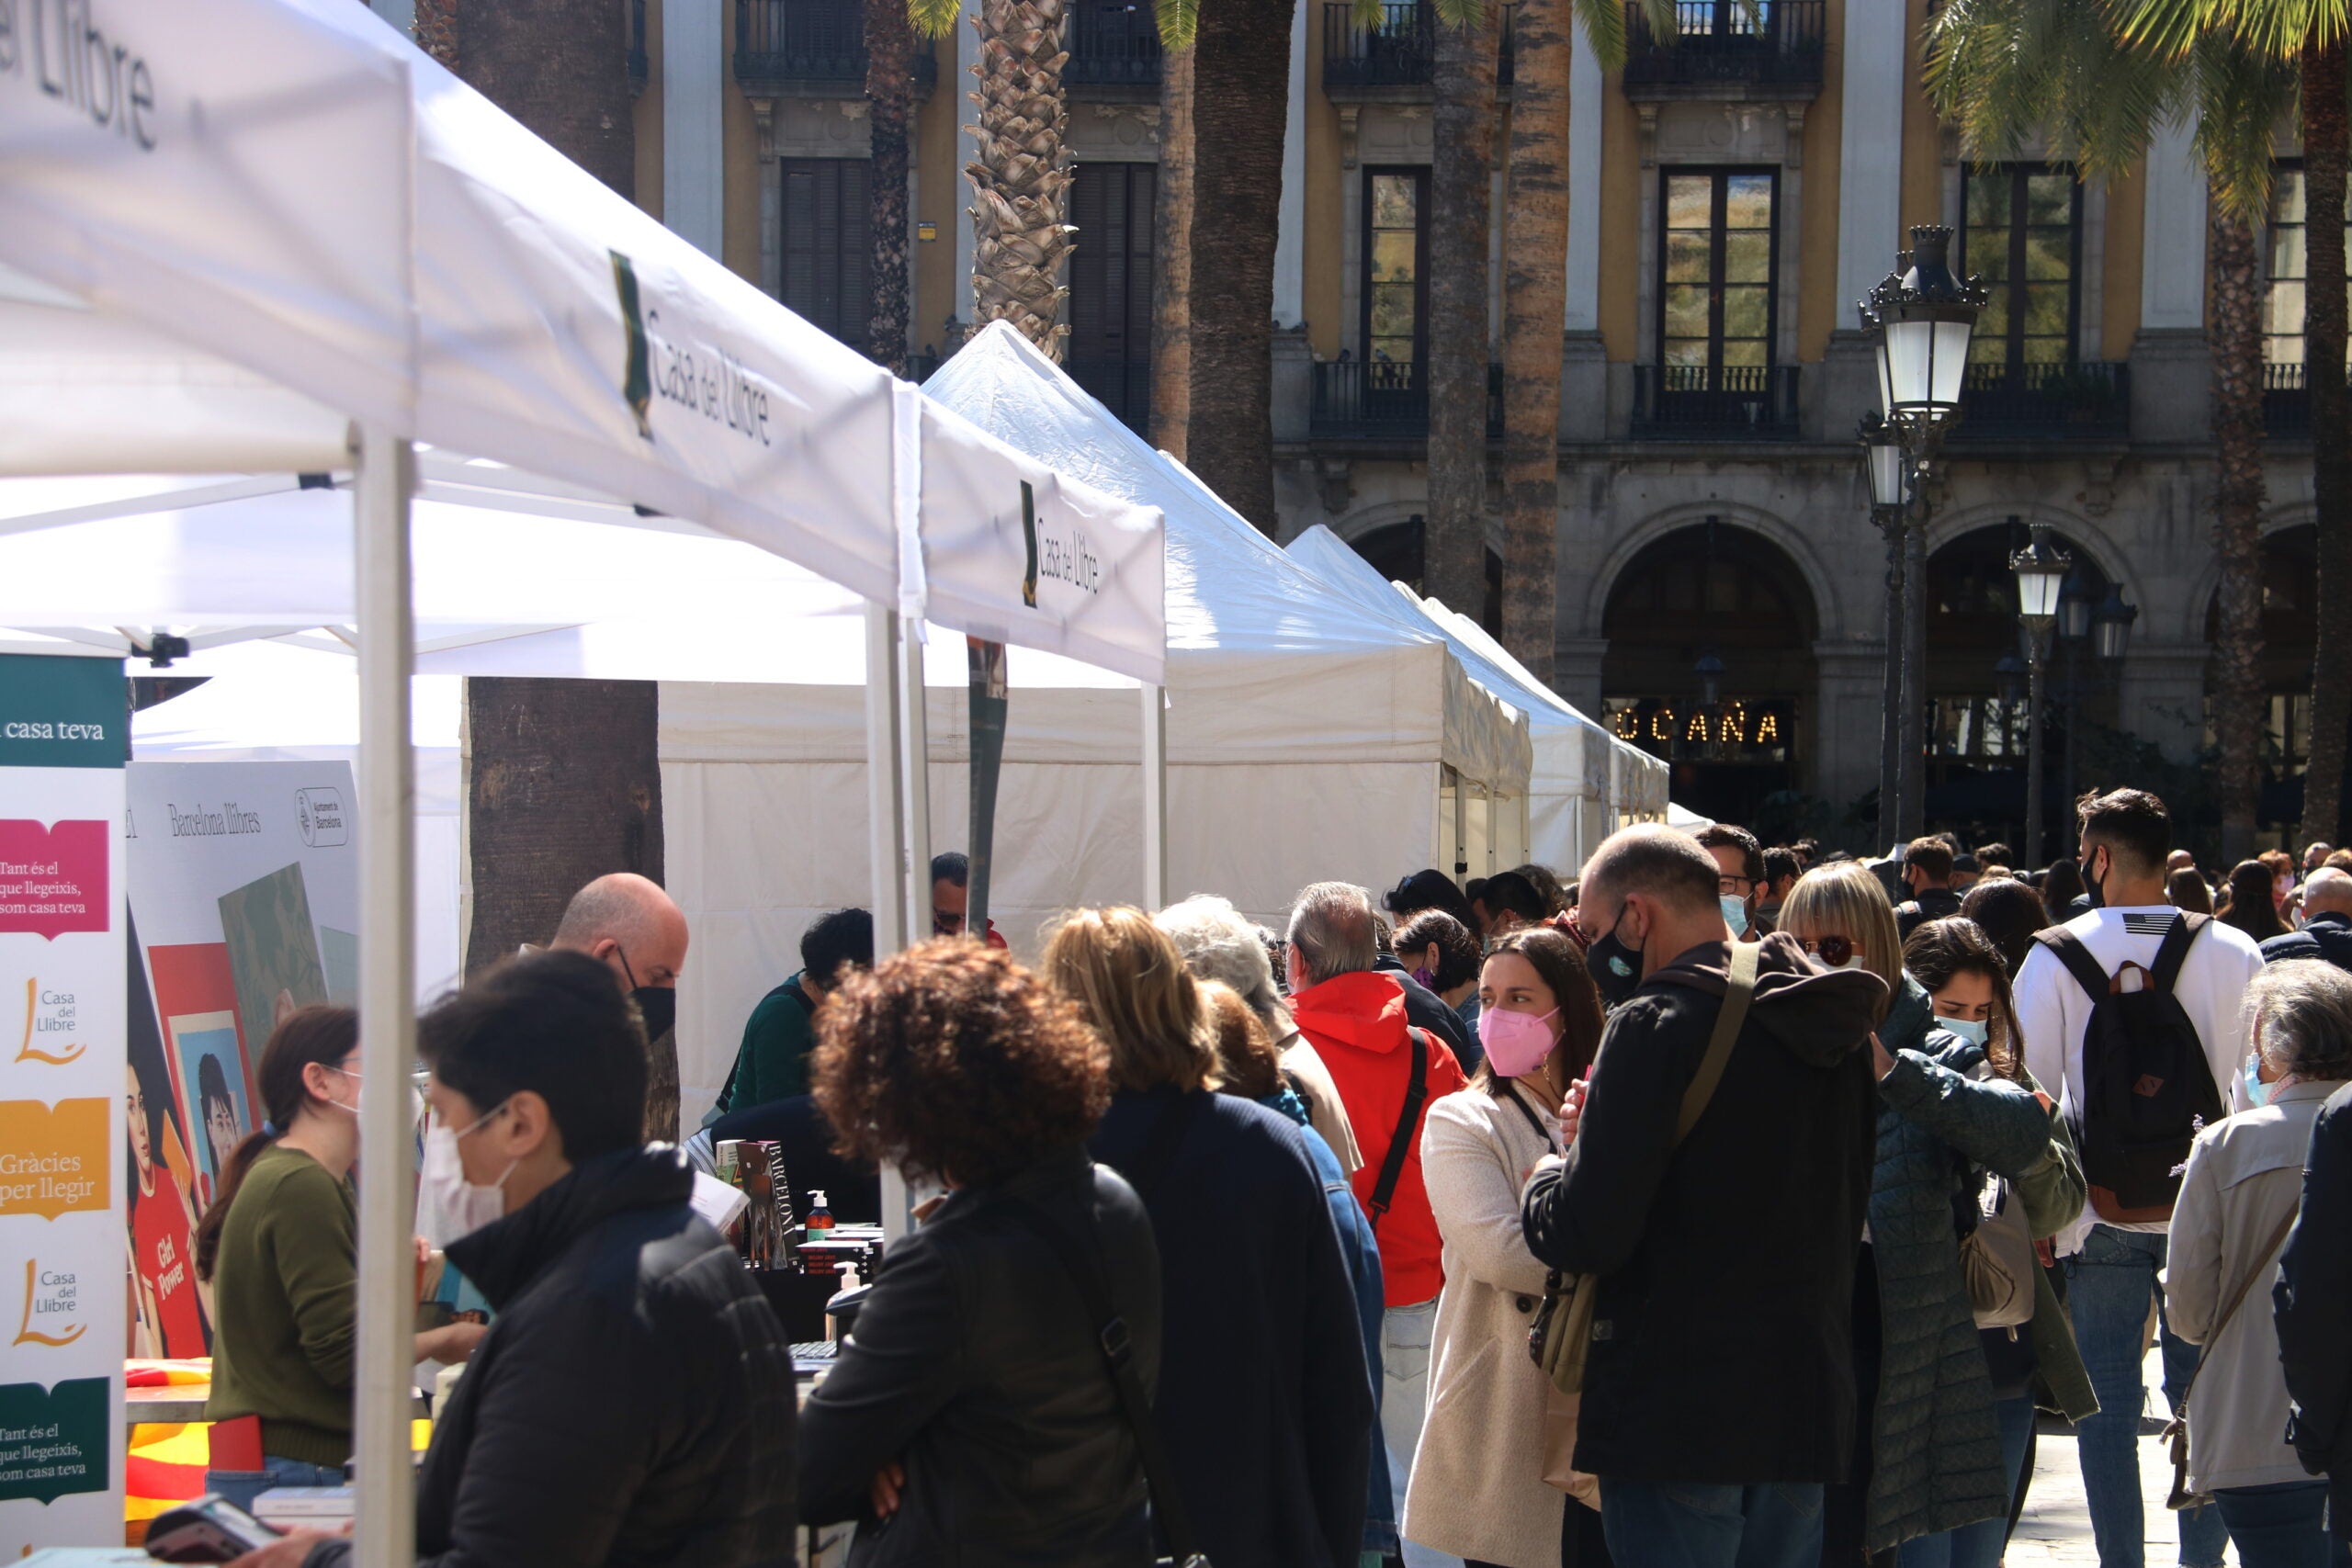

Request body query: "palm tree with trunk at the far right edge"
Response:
[2126, 0, 2352, 841]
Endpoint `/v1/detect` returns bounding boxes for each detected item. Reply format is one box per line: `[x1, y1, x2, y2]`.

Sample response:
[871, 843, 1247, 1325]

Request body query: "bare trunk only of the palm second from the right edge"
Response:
[2209, 197, 2267, 865]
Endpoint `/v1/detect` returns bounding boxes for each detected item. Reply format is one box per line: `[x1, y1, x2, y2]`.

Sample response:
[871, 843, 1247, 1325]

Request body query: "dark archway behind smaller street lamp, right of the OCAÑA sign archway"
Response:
[1924, 517, 2120, 865]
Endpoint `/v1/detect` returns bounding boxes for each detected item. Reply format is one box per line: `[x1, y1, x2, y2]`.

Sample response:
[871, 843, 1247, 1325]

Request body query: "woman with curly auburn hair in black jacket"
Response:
[799, 938, 1159, 1568]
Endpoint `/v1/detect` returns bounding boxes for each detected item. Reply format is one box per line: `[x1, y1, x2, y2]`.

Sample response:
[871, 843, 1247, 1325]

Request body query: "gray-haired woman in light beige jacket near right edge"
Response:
[2164, 959, 2352, 1568]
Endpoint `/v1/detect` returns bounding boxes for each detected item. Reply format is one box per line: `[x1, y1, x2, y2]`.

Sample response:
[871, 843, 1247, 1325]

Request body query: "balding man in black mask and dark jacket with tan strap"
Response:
[1521, 825, 1886, 1568]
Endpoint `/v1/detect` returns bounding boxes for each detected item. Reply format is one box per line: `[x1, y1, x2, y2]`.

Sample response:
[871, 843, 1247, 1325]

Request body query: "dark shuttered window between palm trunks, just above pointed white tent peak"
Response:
[1070, 163, 1159, 430]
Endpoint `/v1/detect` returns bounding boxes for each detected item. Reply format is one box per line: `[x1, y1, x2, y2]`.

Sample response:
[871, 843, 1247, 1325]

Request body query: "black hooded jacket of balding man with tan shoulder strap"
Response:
[1521, 936, 1886, 1485]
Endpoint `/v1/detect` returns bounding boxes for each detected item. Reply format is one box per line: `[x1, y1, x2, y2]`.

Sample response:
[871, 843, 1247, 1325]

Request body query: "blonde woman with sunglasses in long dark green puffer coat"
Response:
[1781, 863, 2051, 1563]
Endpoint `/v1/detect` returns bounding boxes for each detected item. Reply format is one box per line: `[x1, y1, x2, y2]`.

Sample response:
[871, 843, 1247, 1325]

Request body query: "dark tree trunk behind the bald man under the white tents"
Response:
[466, 677, 677, 1140]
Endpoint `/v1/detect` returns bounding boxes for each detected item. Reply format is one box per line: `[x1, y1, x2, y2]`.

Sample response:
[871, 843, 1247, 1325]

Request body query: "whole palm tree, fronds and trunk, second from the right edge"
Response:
[1927, 0, 2296, 861]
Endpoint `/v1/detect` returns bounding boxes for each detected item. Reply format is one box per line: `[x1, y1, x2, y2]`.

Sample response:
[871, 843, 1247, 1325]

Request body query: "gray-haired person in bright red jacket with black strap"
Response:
[1286, 882, 1467, 1568]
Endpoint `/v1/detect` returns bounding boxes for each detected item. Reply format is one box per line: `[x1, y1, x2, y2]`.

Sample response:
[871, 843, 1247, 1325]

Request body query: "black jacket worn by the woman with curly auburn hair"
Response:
[799, 1147, 1159, 1568]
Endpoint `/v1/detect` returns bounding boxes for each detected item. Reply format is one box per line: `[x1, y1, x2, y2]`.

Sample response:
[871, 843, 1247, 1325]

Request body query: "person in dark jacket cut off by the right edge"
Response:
[2269, 1081, 2352, 1551]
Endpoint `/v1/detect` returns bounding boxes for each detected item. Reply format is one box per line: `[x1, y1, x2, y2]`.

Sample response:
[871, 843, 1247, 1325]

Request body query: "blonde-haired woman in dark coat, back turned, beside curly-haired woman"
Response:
[1045, 908, 1376, 1568]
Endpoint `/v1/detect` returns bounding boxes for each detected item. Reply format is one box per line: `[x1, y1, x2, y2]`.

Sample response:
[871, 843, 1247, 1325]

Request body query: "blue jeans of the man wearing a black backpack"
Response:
[2065, 1224, 2230, 1568]
